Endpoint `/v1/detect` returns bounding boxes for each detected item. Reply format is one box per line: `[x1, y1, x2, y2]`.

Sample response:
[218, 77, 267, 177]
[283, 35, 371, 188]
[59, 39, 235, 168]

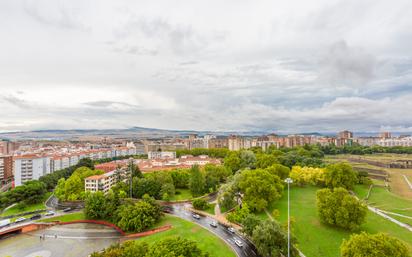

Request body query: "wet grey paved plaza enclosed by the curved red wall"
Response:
[0, 224, 120, 257]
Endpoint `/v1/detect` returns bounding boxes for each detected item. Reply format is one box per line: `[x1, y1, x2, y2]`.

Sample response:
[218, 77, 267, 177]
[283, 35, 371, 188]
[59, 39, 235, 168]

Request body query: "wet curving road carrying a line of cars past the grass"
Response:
[172, 204, 259, 257]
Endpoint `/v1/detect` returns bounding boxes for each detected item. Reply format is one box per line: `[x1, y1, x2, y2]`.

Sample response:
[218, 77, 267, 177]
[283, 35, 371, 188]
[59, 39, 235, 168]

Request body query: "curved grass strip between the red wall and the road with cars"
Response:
[137, 215, 236, 257]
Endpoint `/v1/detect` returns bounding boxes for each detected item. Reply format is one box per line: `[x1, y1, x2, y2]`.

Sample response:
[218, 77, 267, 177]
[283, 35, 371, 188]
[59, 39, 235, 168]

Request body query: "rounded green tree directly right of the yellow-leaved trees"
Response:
[325, 163, 358, 189]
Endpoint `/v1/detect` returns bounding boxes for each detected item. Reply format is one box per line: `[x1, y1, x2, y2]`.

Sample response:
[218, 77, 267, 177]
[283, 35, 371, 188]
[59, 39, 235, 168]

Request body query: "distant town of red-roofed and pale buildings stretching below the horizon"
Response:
[0, 130, 412, 191]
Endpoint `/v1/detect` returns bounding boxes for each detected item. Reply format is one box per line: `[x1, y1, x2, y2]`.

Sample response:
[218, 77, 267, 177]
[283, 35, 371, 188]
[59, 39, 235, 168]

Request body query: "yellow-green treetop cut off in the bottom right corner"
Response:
[341, 232, 410, 257]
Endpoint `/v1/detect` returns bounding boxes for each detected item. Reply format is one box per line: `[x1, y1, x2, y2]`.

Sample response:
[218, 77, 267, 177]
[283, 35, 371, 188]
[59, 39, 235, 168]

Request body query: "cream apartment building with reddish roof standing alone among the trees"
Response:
[84, 170, 117, 194]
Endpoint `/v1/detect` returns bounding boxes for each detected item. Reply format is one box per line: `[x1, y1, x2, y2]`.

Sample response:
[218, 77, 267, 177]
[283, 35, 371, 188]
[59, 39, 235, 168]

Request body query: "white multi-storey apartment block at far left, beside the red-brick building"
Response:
[13, 155, 50, 186]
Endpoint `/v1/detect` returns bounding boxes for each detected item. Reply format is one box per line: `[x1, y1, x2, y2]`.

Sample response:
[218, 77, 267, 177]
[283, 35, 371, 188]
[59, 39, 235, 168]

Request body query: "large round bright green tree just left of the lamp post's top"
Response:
[235, 169, 283, 211]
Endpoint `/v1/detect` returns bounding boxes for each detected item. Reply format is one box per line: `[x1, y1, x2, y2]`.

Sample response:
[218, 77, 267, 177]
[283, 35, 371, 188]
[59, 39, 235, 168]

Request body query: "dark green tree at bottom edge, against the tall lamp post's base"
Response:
[252, 220, 298, 257]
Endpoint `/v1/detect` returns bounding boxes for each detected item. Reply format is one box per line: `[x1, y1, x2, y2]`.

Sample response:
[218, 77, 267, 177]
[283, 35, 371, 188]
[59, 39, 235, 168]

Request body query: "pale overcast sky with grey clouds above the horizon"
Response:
[0, 0, 412, 133]
